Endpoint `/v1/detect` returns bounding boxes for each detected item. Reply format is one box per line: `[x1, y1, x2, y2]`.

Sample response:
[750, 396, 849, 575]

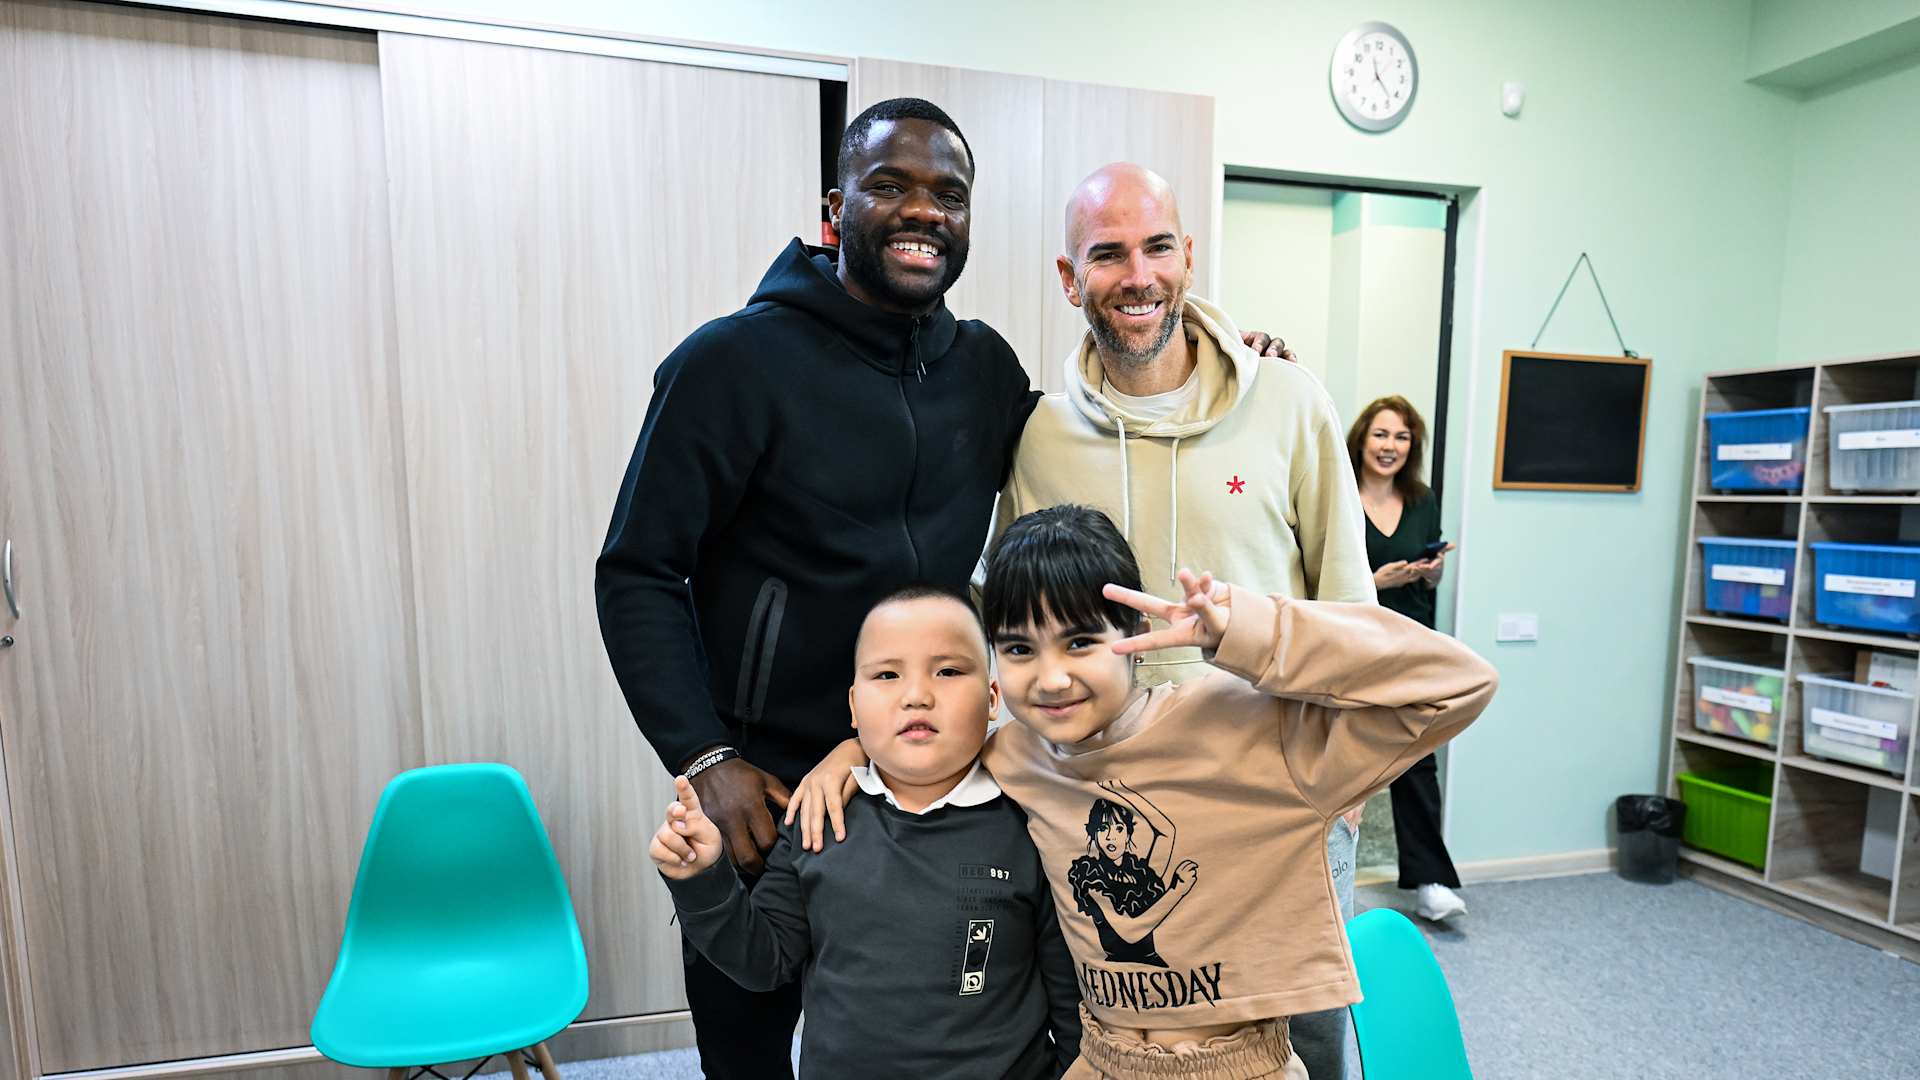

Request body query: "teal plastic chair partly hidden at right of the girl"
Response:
[1346, 907, 1473, 1080]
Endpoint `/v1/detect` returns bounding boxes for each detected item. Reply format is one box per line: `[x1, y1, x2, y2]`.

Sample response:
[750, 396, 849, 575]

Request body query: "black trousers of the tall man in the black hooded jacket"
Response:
[680, 914, 801, 1080]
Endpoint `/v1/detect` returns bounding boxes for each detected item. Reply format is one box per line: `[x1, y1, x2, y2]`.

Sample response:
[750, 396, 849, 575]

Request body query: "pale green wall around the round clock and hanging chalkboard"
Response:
[436, 0, 1795, 861]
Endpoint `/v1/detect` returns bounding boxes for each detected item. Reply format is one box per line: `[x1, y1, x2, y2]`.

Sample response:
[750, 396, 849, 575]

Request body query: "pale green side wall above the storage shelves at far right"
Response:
[1766, 61, 1920, 357]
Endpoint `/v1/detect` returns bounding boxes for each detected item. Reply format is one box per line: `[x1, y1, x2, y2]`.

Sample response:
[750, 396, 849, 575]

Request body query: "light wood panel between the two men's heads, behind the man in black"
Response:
[847, 58, 1060, 384]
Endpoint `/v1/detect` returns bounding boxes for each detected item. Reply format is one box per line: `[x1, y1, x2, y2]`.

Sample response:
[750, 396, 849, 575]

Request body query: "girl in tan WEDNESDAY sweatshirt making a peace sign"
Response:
[789, 505, 1498, 1080]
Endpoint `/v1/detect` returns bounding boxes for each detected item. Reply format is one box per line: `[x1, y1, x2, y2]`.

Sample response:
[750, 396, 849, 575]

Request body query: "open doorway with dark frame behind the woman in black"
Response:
[1219, 169, 1459, 884]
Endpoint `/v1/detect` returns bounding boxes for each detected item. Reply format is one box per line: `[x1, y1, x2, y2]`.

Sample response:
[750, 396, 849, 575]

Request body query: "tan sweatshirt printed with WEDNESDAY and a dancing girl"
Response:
[985, 588, 1498, 1028]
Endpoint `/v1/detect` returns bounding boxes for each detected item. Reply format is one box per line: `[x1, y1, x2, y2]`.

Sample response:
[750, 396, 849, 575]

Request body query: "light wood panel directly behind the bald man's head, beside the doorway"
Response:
[1041, 79, 1233, 390]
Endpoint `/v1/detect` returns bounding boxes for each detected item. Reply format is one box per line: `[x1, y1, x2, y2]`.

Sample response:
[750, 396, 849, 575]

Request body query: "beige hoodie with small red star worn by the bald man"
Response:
[995, 294, 1375, 680]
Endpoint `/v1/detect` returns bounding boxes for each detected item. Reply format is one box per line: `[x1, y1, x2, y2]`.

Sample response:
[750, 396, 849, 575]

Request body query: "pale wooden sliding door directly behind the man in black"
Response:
[380, 35, 831, 1019]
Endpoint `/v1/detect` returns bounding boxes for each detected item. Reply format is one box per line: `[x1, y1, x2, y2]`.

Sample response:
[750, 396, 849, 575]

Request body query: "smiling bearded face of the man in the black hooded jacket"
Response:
[828, 119, 973, 315]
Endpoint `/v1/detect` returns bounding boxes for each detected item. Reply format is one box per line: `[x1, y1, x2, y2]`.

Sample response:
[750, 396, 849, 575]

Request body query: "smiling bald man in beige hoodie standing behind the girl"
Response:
[995, 163, 1375, 1080]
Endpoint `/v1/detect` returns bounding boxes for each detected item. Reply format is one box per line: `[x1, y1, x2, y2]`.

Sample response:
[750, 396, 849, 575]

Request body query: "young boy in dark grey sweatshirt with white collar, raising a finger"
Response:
[649, 586, 1079, 1080]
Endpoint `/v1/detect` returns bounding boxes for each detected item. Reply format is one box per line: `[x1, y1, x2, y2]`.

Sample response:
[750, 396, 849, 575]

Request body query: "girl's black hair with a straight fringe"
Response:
[981, 503, 1140, 640]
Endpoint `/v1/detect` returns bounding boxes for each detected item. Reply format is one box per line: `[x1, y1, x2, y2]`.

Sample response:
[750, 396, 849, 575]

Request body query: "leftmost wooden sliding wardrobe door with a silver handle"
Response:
[0, 0, 420, 1072]
